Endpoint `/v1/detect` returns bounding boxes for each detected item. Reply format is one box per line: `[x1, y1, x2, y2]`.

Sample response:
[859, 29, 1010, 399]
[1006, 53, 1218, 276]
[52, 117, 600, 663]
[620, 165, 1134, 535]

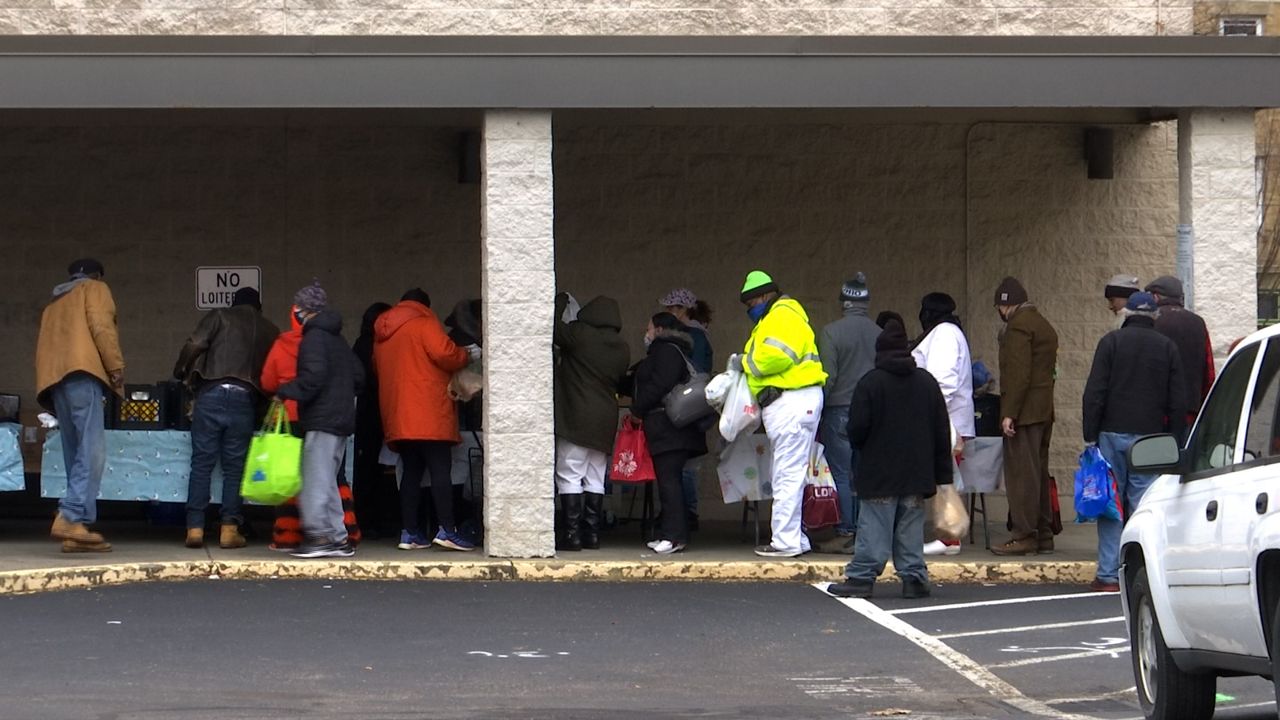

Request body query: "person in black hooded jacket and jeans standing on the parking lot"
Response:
[829, 320, 952, 598]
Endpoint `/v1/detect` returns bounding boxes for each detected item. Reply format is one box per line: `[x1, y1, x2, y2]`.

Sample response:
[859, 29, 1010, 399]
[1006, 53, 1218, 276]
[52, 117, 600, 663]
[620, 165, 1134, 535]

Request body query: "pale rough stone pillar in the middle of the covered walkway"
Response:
[480, 110, 556, 557]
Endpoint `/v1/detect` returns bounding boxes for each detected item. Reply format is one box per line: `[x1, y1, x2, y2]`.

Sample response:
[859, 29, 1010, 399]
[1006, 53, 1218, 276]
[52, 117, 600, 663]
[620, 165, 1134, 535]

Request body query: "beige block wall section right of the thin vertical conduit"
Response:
[968, 123, 1177, 484]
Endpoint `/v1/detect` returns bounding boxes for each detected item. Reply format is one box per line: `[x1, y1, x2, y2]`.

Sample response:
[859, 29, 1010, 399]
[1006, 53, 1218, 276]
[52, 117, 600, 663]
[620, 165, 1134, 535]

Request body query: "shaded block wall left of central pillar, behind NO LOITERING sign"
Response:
[0, 126, 480, 404]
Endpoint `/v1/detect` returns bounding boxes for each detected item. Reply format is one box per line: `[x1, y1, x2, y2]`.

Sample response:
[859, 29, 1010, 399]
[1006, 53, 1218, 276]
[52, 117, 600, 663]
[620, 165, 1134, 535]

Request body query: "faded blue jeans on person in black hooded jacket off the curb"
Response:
[845, 495, 929, 583]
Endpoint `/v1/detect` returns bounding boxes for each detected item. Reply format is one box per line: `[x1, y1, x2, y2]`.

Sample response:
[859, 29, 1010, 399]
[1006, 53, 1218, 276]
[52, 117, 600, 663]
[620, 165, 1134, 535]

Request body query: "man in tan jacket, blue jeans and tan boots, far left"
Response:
[36, 259, 124, 552]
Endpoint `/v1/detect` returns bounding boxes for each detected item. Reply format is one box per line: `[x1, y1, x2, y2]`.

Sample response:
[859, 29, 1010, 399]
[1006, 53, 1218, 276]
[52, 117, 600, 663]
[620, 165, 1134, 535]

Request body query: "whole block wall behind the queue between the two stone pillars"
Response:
[556, 117, 1178, 516]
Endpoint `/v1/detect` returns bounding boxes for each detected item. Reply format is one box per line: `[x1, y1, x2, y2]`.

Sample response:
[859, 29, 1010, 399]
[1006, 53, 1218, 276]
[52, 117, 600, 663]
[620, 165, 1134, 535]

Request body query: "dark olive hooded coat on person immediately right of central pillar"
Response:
[554, 289, 631, 454]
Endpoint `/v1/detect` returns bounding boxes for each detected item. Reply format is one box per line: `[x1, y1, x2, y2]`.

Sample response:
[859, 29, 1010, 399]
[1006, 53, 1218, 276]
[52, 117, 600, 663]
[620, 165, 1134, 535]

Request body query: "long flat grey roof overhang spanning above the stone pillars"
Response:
[0, 36, 1280, 110]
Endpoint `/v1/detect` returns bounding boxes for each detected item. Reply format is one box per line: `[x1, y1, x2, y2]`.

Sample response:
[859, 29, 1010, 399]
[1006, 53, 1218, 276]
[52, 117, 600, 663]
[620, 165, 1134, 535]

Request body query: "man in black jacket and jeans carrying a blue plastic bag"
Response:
[1083, 292, 1189, 592]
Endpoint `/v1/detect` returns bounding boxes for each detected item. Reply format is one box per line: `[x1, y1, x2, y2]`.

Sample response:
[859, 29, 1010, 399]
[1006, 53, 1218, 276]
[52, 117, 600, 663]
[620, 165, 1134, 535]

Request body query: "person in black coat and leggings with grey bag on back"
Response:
[631, 313, 707, 555]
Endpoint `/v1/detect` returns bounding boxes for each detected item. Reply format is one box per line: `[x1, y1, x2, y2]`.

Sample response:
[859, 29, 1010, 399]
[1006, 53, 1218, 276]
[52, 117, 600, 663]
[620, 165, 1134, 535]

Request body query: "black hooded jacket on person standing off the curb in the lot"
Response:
[849, 322, 954, 497]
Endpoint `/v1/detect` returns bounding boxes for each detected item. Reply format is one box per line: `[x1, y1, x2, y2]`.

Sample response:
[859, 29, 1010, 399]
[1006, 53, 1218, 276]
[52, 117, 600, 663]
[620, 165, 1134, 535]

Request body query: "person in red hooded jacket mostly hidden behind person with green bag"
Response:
[259, 299, 361, 551]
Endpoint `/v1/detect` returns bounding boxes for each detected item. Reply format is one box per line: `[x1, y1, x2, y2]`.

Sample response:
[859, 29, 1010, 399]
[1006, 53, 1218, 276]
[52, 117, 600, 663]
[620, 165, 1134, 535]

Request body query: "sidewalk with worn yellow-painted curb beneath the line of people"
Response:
[0, 521, 1097, 594]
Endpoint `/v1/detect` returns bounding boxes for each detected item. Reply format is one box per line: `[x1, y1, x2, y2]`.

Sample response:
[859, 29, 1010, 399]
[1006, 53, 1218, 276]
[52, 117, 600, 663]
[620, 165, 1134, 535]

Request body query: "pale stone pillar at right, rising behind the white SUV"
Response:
[1178, 110, 1258, 357]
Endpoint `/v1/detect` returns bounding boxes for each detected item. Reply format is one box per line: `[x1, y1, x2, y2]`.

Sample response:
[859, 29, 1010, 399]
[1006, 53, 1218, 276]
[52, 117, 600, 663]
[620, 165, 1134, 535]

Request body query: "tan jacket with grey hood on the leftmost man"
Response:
[36, 277, 124, 411]
